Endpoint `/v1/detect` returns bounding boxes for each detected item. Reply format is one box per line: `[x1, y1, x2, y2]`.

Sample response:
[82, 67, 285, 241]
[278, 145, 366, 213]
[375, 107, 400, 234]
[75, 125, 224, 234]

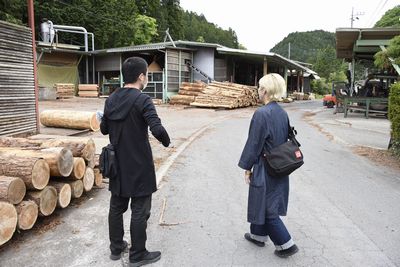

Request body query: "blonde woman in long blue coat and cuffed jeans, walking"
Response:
[239, 73, 298, 258]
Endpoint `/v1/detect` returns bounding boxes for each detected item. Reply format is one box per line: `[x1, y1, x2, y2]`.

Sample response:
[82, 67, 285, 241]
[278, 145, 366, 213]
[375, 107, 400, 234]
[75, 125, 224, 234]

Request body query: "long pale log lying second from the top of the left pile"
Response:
[0, 147, 74, 177]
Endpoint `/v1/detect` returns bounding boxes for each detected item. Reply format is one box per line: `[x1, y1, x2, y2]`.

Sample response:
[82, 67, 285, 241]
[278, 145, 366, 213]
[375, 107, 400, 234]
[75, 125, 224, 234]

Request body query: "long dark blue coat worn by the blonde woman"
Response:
[239, 102, 289, 225]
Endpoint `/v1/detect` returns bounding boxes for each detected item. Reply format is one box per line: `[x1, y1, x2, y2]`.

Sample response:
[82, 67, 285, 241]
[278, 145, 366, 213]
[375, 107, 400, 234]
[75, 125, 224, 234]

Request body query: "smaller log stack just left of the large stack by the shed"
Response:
[169, 82, 206, 105]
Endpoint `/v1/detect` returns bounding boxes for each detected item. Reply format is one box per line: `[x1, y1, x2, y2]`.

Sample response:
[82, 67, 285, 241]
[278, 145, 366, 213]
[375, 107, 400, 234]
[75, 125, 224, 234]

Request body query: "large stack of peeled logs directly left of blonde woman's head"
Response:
[190, 81, 258, 109]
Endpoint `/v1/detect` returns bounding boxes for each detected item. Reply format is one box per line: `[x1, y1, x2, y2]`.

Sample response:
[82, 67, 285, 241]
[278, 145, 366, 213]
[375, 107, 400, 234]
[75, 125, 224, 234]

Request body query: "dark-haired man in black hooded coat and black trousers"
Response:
[100, 57, 170, 266]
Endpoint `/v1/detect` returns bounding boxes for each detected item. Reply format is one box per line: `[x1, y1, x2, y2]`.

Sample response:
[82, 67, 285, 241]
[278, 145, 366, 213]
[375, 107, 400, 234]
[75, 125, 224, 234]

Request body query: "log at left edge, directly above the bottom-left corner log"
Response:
[0, 176, 26, 204]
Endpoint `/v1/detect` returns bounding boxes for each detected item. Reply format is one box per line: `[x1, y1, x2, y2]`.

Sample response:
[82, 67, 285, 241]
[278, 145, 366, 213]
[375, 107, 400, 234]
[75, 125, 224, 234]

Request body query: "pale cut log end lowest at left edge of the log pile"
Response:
[0, 201, 18, 246]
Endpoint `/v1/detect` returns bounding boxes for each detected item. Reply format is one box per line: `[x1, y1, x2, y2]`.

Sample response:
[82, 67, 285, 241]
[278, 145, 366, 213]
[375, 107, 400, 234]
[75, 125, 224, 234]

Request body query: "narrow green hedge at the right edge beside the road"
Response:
[389, 83, 400, 156]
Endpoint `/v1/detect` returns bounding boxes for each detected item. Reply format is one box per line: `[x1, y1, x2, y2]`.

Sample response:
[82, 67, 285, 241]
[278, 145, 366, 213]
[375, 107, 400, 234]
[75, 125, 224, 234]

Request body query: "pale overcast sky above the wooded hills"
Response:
[180, 0, 400, 52]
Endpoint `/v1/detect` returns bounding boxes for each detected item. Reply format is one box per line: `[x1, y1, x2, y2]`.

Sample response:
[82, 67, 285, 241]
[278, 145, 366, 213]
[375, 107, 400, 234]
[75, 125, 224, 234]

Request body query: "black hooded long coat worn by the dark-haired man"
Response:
[100, 88, 170, 197]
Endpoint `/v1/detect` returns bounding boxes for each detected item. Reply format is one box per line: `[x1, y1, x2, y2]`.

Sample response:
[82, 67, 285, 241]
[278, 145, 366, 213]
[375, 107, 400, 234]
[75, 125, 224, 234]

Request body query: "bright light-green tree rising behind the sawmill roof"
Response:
[132, 15, 158, 44]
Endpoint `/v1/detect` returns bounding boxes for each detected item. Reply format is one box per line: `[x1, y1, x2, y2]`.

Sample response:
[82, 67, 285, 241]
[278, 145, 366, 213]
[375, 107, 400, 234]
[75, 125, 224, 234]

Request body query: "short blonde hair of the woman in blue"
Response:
[258, 73, 286, 100]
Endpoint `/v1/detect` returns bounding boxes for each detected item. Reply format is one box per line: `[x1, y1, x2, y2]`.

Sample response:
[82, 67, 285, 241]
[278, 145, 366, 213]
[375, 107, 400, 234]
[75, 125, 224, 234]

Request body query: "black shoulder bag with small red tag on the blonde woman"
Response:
[263, 121, 304, 177]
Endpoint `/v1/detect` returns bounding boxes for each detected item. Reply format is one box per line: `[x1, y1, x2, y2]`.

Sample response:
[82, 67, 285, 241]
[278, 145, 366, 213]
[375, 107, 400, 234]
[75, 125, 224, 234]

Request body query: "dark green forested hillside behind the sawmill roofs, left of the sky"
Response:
[0, 0, 238, 49]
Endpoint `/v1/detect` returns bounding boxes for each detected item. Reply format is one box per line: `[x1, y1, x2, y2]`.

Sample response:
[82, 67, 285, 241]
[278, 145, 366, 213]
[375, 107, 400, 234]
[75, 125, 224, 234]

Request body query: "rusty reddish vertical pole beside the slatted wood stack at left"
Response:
[27, 0, 40, 133]
